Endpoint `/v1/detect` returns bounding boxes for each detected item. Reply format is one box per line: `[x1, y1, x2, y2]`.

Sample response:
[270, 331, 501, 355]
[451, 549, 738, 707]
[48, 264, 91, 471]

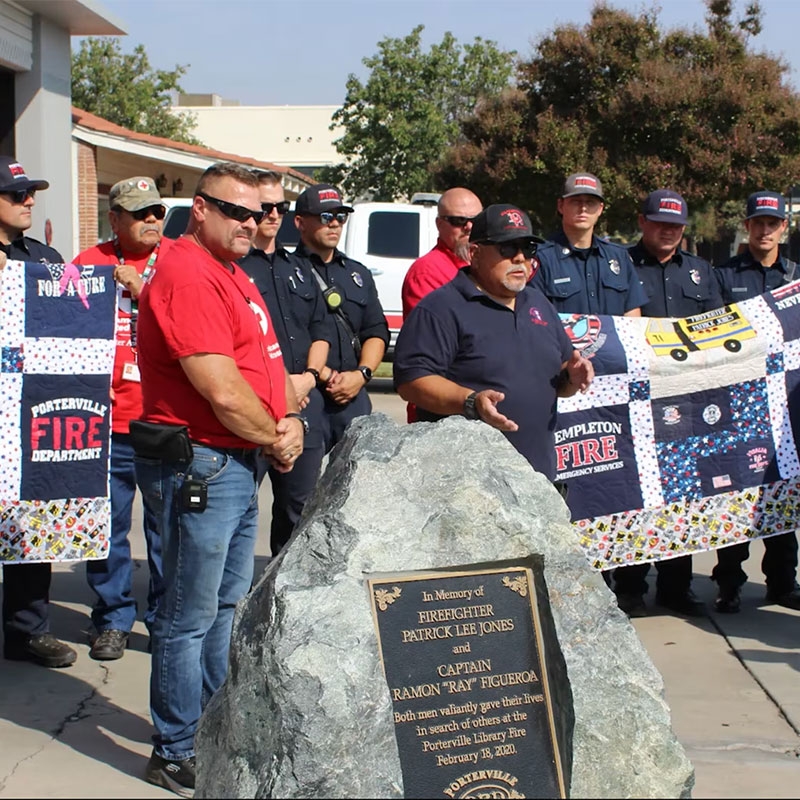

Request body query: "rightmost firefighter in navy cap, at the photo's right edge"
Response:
[711, 192, 800, 614]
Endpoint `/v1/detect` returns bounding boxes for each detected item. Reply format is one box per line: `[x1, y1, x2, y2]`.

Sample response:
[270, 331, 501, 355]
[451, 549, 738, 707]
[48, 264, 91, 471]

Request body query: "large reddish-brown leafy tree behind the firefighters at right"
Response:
[437, 0, 800, 238]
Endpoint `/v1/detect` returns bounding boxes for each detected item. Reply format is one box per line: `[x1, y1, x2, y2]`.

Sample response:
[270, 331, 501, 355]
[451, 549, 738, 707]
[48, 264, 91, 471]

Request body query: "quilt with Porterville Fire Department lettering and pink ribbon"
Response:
[0, 261, 117, 564]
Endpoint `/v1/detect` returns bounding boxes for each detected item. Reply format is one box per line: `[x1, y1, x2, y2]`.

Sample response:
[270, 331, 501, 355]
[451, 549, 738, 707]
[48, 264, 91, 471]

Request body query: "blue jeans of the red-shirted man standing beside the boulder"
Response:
[136, 444, 258, 760]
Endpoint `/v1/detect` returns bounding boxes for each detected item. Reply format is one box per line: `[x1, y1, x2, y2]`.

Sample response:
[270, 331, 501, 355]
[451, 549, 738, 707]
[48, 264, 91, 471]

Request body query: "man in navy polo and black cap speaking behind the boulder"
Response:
[394, 204, 594, 480]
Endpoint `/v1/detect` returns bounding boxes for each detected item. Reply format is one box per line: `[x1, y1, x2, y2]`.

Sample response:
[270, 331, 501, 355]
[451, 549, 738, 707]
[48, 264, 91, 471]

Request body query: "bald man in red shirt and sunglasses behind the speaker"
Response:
[400, 186, 483, 422]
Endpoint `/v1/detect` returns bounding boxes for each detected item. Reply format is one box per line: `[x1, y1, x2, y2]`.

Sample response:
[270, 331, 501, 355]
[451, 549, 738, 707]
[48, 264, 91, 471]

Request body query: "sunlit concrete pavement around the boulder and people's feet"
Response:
[0, 392, 800, 798]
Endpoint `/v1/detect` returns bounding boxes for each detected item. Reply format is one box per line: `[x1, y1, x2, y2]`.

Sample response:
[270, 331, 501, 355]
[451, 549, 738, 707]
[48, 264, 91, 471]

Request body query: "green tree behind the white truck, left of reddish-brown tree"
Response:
[320, 25, 516, 200]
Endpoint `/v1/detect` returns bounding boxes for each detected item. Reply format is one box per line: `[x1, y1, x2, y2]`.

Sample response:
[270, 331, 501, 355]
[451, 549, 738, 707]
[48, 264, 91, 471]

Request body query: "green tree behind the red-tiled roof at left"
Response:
[72, 37, 200, 144]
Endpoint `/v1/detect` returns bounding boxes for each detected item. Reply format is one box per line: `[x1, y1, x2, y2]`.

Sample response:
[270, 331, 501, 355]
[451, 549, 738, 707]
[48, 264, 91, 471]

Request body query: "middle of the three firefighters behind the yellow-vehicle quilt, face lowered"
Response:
[614, 189, 723, 617]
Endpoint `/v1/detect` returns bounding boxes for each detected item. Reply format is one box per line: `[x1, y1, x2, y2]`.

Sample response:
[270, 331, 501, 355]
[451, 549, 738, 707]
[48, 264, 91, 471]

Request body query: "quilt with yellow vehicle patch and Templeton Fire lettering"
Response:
[555, 281, 800, 570]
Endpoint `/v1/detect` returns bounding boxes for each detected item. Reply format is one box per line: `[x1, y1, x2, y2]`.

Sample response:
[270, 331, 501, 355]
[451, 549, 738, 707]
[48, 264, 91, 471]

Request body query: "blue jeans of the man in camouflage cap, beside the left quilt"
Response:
[86, 433, 164, 633]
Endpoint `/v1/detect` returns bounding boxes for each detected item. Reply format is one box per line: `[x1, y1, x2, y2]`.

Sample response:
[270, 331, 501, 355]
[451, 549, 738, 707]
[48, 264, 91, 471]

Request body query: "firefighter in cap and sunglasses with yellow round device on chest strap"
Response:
[292, 183, 389, 453]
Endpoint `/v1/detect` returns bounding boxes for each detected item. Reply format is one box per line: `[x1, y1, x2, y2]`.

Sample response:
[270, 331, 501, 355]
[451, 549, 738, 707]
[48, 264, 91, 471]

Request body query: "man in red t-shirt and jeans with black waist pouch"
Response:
[131, 164, 305, 796]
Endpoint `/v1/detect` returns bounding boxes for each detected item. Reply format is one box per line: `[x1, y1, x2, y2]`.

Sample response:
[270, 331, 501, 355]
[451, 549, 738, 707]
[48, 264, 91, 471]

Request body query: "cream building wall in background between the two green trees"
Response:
[173, 105, 344, 173]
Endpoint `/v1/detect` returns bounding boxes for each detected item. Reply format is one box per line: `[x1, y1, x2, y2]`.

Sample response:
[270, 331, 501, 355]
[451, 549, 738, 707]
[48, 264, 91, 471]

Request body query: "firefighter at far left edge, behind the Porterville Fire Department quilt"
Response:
[0, 156, 78, 667]
